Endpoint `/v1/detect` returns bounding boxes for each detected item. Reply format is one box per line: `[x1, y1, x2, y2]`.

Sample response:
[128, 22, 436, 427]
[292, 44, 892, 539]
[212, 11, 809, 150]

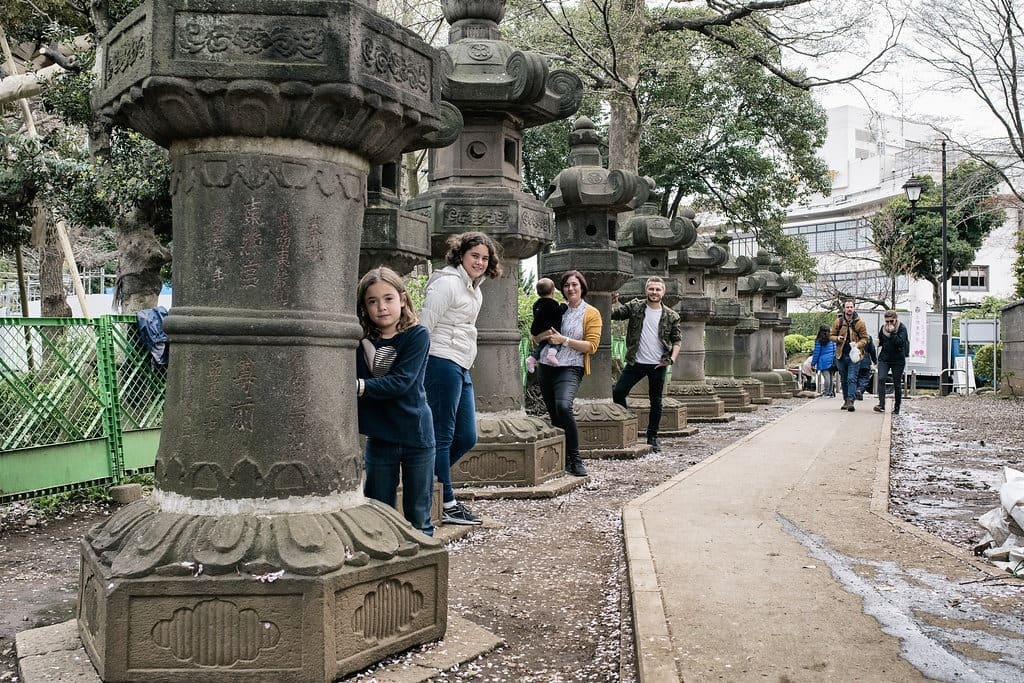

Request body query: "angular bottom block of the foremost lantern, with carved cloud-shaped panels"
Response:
[79, 547, 447, 683]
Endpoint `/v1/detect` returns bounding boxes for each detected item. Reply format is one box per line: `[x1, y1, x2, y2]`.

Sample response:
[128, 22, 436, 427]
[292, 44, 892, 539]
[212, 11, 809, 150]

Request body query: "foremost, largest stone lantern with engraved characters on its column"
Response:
[78, 0, 451, 683]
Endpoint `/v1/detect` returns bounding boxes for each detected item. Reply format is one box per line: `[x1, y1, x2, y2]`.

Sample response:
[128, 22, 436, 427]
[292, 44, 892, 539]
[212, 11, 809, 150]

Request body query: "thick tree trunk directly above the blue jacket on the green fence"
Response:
[114, 218, 171, 313]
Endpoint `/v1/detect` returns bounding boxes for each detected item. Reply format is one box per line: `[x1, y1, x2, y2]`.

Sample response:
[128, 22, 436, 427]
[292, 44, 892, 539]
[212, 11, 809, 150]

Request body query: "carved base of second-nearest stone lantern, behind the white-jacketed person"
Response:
[452, 413, 565, 487]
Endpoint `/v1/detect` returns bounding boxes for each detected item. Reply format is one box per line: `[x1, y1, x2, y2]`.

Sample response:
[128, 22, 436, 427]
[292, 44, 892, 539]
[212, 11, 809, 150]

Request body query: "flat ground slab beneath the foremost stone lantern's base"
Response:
[15, 611, 503, 683]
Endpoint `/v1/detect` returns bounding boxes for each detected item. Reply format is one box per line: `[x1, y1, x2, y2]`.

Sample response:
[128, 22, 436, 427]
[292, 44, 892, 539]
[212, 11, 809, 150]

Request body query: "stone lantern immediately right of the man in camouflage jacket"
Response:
[666, 233, 736, 422]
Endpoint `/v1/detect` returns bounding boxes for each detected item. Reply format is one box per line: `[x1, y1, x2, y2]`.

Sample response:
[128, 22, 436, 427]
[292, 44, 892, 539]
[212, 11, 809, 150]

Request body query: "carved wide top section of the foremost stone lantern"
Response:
[92, 0, 462, 162]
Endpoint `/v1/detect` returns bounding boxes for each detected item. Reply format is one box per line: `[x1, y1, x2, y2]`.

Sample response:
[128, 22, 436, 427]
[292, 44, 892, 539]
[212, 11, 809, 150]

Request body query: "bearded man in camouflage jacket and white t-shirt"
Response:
[611, 275, 683, 453]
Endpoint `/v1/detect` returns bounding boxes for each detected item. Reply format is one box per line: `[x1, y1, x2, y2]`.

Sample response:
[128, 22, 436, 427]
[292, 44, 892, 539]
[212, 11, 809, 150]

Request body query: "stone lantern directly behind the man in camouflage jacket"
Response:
[618, 183, 697, 436]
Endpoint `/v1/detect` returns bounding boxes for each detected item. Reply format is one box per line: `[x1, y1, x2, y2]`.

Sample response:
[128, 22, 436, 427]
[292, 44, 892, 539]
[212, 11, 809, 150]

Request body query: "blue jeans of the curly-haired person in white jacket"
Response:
[423, 355, 476, 503]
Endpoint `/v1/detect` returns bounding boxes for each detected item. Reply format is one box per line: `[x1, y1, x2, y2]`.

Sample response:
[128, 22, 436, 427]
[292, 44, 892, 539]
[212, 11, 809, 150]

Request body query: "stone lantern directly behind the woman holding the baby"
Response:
[539, 117, 650, 458]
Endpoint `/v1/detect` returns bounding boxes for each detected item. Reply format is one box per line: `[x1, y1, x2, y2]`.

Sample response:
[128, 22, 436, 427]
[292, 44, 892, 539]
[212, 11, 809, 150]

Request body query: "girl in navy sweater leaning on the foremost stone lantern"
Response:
[355, 267, 434, 536]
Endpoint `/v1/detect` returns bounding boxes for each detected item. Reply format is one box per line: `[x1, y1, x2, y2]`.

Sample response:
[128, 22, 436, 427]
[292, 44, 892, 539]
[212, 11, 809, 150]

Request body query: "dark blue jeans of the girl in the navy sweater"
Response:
[362, 438, 434, 536]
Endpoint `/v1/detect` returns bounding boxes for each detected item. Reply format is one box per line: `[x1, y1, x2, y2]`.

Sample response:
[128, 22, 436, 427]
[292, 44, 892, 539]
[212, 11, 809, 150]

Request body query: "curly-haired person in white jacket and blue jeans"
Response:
[420, 232, 502, 525]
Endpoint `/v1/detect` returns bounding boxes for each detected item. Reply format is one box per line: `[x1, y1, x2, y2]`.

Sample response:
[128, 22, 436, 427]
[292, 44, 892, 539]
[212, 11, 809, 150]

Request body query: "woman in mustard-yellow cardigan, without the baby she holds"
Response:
[537, 270, 601, 477]
